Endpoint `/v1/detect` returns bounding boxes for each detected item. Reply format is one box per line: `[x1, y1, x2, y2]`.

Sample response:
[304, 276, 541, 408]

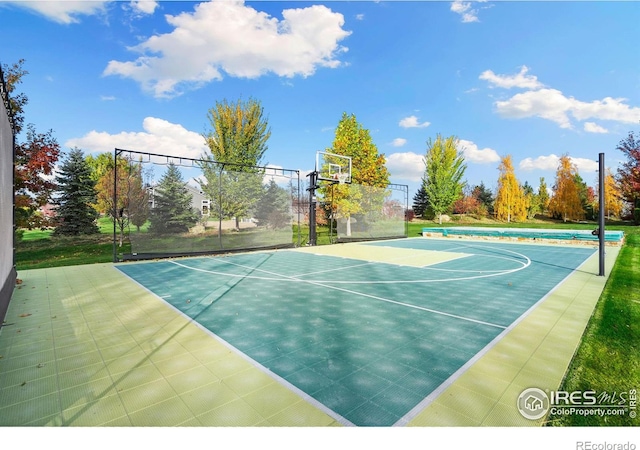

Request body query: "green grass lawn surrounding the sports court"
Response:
[11, 219, 640, 426]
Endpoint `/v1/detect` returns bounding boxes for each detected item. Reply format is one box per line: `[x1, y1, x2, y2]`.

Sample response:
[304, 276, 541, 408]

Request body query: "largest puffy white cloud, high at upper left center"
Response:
[104, 0, 351, 97]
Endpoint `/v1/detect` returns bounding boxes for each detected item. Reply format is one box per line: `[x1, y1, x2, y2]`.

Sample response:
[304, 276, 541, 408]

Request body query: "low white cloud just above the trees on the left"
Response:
[65, 117, 208, 158]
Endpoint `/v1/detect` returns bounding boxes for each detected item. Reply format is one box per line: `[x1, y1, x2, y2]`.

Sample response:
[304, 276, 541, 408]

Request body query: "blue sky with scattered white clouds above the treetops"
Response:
[0, 0, 640, 202]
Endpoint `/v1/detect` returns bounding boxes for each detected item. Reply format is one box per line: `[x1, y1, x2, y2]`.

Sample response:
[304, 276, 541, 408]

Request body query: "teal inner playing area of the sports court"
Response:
[118, 239, 608, 426]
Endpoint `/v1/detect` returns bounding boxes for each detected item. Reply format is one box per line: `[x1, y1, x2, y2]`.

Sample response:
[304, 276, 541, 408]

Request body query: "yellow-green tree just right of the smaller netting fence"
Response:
[423, 134, 467, 223]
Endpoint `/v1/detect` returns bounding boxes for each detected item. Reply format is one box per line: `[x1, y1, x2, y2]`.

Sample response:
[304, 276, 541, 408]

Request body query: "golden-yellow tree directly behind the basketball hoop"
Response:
[318, 112, 389, 236]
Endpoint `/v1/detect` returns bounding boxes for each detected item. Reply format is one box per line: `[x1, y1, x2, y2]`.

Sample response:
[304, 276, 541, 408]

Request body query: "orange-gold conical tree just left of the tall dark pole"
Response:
[549, 155, 585, 222]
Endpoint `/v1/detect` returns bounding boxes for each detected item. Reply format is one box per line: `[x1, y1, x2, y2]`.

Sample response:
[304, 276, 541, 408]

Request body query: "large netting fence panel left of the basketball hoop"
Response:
[114, 149, 303, 260]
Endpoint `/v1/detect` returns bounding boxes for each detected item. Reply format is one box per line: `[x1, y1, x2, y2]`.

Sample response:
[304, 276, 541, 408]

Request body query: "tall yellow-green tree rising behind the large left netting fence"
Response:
[199, 99, 271, 229]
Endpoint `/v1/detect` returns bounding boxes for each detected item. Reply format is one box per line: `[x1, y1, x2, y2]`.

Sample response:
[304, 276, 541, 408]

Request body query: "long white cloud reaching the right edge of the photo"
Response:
[495, 89, 640, 128]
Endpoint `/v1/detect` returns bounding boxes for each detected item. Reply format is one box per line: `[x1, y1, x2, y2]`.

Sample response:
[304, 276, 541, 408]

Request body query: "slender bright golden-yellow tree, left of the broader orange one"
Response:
[494, 155, 527, 223]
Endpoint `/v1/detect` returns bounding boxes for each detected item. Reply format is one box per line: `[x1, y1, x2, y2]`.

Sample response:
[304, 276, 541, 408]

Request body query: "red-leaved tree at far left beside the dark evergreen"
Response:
[14, 124, 60, 229]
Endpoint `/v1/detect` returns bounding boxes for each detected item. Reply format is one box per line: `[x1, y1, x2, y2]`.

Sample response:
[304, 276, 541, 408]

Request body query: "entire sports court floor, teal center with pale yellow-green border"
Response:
[0, 239, 618, 427]
